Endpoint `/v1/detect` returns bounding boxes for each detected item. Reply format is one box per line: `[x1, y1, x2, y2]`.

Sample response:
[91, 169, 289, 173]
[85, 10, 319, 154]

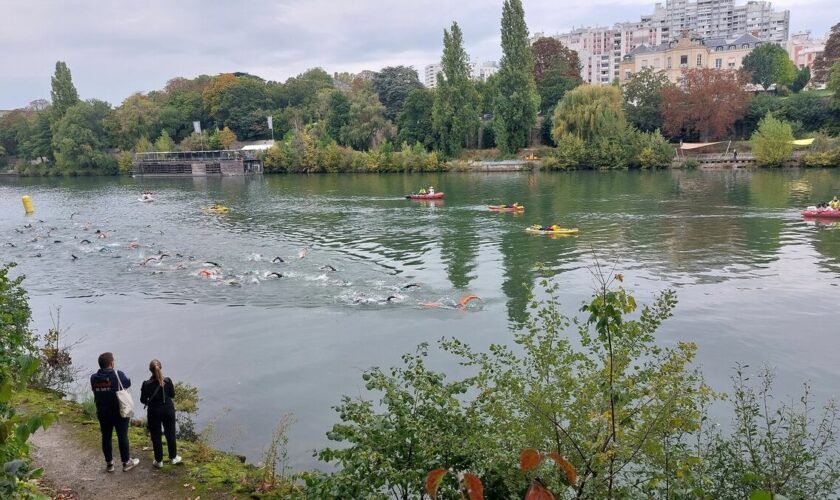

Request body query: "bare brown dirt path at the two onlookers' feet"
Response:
[30, 422, 195, 500]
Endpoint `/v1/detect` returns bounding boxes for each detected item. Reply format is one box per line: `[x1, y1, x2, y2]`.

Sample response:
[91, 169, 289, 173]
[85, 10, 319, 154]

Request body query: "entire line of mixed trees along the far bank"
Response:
[0, 9, 840, 175]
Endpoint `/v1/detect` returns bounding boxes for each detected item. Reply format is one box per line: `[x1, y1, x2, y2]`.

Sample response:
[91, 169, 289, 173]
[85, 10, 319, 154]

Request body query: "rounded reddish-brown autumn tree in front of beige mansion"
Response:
[661, 68, 751, 141]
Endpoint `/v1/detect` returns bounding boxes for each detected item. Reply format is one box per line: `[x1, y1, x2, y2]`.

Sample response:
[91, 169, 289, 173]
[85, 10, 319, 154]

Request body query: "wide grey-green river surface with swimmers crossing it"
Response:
[0, 170, 840, 467]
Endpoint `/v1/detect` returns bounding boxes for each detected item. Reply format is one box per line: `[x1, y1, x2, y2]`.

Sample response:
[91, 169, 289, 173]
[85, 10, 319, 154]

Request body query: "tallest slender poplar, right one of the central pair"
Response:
[493, 0, 540, 154]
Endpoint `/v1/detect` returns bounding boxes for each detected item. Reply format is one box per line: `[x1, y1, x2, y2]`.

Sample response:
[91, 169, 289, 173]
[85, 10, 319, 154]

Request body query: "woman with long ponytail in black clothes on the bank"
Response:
[140, 359, 181, 469]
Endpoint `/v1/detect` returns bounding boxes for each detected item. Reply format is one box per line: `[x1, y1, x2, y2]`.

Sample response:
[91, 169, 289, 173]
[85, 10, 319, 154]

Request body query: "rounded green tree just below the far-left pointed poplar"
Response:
[52, 99, 116, 175]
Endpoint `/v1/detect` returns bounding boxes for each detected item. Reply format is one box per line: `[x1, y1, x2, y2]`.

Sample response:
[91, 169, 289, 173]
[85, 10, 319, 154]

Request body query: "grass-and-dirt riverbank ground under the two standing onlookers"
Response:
[14, 389, 296, 499]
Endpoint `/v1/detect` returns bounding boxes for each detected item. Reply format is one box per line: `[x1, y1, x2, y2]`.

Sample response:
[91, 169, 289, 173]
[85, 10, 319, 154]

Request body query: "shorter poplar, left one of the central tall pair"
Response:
[432, 22, 479, 156]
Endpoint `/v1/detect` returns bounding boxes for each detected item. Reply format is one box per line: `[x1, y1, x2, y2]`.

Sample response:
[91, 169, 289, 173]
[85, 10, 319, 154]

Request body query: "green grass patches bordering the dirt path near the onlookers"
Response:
[15, 389, 299, 498]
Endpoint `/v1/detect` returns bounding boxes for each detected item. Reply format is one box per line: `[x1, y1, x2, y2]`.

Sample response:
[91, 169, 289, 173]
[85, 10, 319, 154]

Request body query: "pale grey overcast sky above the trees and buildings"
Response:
[0, 0, 840, 109]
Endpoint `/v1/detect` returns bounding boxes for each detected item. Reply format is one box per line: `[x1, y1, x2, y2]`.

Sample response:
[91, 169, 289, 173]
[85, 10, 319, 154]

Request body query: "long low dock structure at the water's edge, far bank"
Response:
[132, 149, 263, 177]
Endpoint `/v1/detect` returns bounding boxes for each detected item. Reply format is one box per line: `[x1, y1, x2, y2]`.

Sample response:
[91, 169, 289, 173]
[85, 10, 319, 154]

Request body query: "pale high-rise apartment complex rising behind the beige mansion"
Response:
[532, 0, 790, 85]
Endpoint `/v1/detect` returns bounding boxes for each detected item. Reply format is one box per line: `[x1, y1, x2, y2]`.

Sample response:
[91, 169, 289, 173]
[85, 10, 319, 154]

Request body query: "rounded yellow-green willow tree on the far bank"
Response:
[552, 85, 627, 143]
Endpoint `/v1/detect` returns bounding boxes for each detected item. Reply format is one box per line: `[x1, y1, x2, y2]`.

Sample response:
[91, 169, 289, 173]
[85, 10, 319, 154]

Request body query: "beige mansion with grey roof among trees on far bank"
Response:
[620, 32, 765, 83]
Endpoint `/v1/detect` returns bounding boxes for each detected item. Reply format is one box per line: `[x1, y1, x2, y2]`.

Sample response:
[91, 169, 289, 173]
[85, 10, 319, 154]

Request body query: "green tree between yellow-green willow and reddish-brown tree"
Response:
[622, 67, 669, 132]
